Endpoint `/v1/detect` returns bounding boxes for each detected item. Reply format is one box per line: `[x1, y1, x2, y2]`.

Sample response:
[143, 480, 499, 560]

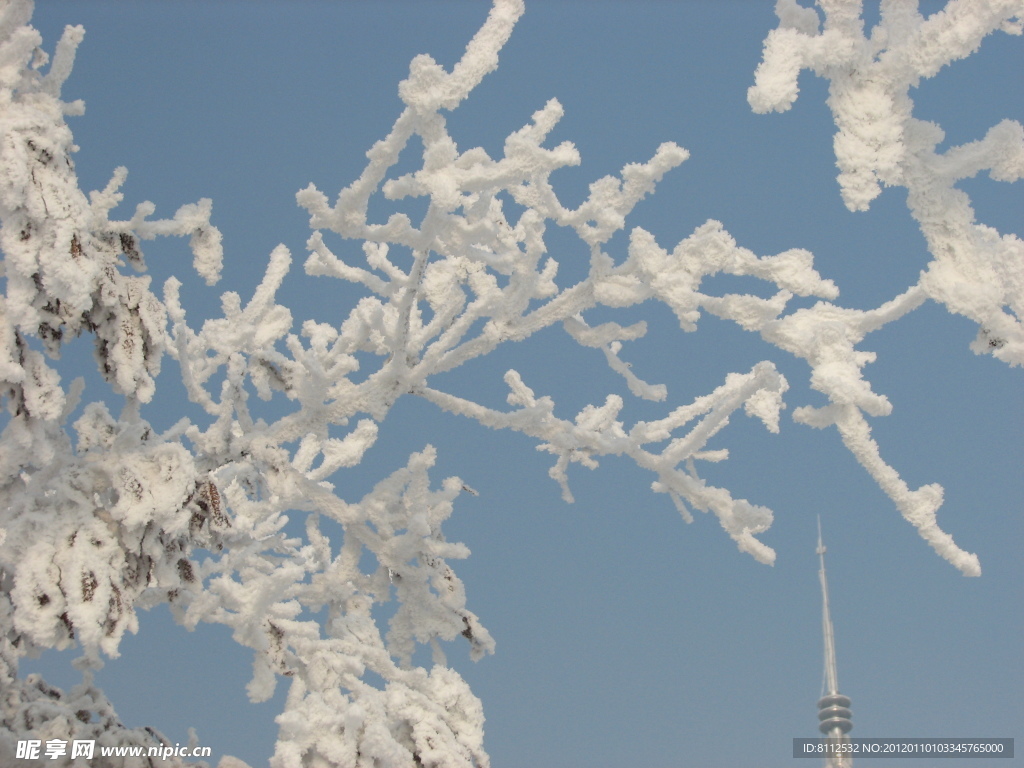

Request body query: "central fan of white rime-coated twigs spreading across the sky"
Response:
[298, 2, 837, 562]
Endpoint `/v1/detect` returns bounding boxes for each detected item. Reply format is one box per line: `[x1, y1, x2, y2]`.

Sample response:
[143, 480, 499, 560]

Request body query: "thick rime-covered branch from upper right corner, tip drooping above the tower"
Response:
[748, 0, 1024, 575]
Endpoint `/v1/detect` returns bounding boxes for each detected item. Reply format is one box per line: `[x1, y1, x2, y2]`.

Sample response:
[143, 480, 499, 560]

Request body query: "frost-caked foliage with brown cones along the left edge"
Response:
[0, 1, 220, 764]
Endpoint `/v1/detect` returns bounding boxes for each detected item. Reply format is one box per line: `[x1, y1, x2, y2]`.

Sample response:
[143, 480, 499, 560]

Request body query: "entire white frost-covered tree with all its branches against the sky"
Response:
[0, 0, 1024, 768]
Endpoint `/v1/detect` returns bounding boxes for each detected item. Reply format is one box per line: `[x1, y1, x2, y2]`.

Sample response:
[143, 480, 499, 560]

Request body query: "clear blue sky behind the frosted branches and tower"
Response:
[26, 0, 1024, 768]
